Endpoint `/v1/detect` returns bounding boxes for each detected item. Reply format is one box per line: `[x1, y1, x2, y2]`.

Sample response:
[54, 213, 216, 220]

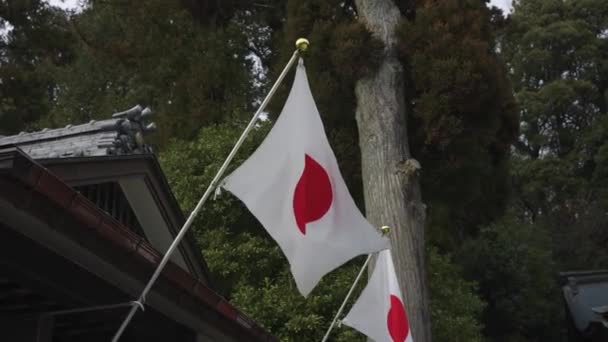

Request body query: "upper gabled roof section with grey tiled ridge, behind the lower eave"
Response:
[0, 105, 209, 282]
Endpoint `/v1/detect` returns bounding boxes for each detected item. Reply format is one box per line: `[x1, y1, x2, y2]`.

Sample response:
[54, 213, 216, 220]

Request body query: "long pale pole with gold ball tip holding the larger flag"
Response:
[112, 38, 309, 342]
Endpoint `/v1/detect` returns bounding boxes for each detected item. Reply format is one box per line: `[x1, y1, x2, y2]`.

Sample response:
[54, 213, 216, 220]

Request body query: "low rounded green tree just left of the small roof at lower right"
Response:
[459, 215, 562, 341]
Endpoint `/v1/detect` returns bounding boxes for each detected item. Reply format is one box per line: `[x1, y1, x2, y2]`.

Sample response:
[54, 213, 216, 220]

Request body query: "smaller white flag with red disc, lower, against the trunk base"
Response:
[342, 250, 413, 342]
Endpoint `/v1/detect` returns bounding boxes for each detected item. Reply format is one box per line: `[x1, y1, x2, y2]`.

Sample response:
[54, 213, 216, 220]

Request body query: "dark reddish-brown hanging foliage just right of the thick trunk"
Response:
[397, 0, 517, 248]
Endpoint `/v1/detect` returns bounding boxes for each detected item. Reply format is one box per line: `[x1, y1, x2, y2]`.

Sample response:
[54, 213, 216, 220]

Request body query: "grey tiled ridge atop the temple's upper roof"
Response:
[0, 105, 156, 159]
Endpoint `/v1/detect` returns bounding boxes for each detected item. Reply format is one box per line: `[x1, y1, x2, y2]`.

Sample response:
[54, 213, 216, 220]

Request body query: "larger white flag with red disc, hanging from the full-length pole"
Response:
[222, 59, 389, 296]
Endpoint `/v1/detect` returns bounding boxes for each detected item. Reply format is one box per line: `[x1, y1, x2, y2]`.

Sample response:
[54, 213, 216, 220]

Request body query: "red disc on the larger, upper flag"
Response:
[293, 154, 333, 235]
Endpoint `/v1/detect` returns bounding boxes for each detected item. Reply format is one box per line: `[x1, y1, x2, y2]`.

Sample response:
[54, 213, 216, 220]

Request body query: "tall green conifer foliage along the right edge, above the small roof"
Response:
[501, 0, 608, 271]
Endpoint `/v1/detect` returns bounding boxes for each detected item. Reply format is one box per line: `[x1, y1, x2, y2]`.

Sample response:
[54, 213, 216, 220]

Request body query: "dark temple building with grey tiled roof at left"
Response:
[0, 106, 276, 342]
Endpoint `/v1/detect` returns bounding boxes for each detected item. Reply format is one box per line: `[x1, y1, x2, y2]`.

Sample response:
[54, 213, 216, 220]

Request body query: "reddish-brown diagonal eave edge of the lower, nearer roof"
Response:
[0, 147, 276, 341]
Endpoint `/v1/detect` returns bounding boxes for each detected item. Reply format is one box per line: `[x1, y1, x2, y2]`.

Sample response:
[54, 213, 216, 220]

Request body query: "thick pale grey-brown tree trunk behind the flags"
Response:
[355, 0, 431, 342]
